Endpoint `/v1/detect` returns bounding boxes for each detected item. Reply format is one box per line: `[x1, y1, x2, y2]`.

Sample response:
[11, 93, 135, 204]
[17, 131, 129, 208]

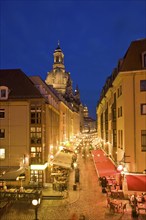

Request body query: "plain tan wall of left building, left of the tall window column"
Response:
[0, 101, 30, 167]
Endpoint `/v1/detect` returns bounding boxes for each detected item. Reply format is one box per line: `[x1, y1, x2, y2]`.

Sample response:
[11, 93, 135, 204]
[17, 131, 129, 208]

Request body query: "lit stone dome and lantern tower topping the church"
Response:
[45, 42, 69, 95]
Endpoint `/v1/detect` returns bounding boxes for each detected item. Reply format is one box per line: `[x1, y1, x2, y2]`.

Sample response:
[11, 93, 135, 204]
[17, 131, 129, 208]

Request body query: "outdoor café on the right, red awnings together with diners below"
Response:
[92, 149, 146, 216]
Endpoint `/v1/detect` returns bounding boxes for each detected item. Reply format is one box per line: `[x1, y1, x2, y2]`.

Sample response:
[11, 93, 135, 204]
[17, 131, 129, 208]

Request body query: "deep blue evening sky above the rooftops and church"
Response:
[0, 0, 146, 118]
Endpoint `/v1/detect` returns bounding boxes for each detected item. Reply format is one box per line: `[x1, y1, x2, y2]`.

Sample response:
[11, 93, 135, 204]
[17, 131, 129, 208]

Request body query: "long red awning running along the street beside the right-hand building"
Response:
[92, 149, 119, 177]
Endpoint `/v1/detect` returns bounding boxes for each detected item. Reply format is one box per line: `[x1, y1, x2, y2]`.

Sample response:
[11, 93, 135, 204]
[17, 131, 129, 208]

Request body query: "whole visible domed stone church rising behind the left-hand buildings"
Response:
[45, 42, 81, 112]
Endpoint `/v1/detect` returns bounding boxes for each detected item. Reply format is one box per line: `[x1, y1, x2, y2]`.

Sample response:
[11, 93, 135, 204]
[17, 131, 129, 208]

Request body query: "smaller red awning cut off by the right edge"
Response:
[126, 174, 146, 192]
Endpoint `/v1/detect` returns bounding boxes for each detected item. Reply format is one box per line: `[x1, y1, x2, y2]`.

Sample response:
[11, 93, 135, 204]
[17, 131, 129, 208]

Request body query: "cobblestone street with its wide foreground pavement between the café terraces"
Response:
[1, 154, 144, 220]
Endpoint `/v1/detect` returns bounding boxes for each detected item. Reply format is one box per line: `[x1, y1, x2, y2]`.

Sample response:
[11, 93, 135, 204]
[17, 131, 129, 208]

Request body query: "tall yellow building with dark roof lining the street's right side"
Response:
[96, 39, 146, 172]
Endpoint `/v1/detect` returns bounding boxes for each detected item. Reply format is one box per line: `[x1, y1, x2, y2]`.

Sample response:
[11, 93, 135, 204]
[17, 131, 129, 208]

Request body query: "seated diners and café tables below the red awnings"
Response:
[99, 176, 146, 217]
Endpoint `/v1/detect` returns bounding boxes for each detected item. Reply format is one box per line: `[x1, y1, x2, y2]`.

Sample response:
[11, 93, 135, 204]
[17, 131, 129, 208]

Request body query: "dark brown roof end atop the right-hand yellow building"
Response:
[120, 38, 146, 72]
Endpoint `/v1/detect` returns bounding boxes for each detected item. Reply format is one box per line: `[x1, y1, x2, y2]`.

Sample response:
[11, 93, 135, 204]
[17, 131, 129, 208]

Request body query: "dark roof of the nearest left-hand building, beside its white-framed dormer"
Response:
[0, 69, 42, 99]
